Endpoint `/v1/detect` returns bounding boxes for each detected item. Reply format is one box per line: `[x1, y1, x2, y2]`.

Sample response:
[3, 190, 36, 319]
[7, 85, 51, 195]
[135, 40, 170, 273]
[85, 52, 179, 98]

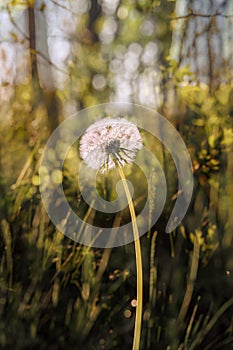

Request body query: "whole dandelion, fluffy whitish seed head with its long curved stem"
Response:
[80, 118, 143, 350]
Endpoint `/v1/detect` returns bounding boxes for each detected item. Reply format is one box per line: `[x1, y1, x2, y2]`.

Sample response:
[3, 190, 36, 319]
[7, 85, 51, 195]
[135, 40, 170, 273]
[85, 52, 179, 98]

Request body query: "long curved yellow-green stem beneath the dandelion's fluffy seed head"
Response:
[117, 164, 143, 350]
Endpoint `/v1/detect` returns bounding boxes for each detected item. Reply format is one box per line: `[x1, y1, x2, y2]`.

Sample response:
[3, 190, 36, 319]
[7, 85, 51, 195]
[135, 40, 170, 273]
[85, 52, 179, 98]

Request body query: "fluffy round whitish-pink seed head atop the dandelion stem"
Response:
[79, 118, 142, 173]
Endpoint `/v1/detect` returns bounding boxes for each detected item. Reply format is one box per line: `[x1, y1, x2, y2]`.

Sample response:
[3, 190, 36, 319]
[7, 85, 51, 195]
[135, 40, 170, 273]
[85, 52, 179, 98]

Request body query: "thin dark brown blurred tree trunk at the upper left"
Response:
[27, 1, 59, 133]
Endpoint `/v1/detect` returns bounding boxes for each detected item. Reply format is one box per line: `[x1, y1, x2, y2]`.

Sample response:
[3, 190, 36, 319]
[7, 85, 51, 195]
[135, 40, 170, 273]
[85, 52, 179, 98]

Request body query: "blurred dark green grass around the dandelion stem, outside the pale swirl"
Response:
[0, 89, 233, 350]
